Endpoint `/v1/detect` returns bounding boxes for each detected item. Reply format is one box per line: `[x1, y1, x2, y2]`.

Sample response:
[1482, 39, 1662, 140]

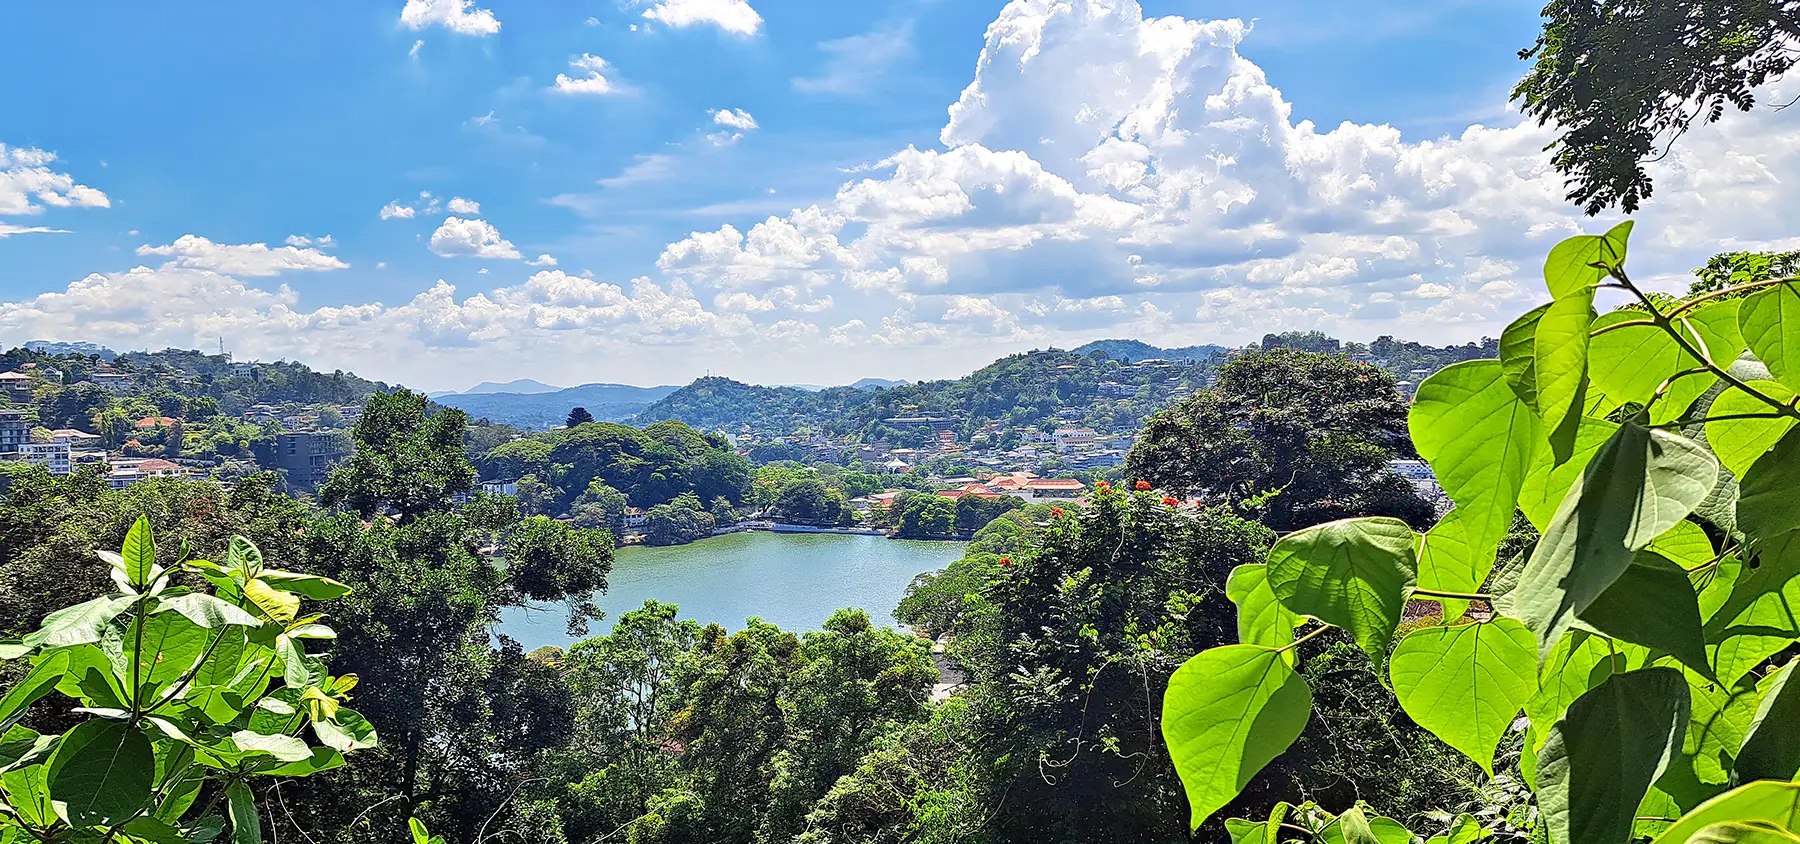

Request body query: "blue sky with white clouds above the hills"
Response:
[0, 0, 1787, 389]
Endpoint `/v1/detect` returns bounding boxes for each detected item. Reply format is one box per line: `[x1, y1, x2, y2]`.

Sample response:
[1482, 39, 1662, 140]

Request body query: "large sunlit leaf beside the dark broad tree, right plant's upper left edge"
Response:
[1406, 360, 1543, 556]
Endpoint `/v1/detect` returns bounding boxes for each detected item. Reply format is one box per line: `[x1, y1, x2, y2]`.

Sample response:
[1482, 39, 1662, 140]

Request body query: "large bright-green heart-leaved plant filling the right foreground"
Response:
[1163, 223, 1800, 844]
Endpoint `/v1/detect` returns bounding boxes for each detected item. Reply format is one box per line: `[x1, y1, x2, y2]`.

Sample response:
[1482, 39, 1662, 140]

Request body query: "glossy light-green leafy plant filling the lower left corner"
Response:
[0, 516, 376, 844]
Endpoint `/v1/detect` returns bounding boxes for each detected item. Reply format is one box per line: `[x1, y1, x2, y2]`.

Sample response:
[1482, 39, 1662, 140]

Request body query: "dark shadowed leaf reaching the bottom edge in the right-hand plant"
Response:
[1537, 668, 1688, 844]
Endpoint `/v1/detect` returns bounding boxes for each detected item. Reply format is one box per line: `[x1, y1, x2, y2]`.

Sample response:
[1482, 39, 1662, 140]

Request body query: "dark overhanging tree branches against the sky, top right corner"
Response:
[1512, 0, 1800, 214]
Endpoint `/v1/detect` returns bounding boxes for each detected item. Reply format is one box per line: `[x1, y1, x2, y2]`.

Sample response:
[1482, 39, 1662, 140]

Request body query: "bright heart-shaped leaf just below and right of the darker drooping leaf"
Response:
[1388, 617, 1537, 776]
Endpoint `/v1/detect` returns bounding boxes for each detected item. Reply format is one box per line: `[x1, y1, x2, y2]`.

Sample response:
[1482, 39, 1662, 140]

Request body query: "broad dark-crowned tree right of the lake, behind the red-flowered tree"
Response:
[1125, 349, 1435, 531]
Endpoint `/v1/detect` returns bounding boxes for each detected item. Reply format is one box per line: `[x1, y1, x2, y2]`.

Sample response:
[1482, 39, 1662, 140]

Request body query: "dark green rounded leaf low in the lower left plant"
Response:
[49, 720, 157, 826]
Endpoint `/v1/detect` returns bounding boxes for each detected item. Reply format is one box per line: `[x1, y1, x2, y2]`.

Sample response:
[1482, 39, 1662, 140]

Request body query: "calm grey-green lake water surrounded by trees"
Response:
[499, 531, 963, 651]
